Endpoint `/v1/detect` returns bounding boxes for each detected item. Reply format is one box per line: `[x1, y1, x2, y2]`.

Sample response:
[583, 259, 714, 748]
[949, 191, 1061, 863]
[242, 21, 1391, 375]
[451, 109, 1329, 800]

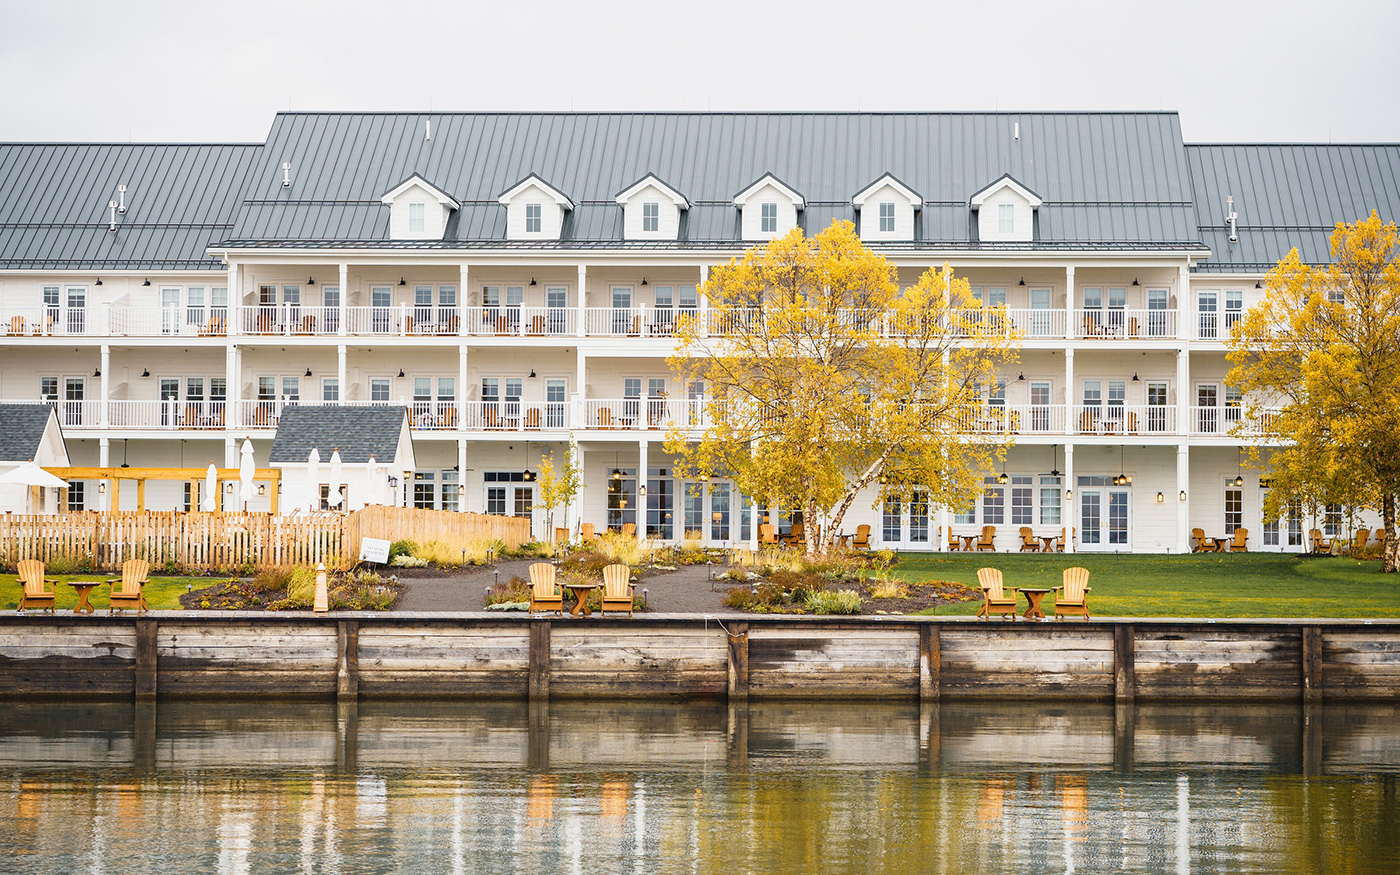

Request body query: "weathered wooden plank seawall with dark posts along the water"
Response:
[0, 612, 1400, 701]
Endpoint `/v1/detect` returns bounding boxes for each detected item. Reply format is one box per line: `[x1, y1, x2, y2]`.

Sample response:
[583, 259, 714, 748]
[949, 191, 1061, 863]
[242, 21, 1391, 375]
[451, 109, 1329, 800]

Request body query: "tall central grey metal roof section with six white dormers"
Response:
[230, 112, 1198, 246]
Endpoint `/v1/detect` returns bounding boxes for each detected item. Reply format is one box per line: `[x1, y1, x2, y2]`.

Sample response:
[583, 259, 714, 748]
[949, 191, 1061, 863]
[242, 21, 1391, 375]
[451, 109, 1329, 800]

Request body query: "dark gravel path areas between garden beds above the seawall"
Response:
[396, 560, 741, 616]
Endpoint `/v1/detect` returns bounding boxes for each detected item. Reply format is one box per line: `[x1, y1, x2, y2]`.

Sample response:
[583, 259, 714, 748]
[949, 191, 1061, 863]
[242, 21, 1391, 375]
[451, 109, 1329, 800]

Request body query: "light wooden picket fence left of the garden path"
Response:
[0, 505, 531, 571]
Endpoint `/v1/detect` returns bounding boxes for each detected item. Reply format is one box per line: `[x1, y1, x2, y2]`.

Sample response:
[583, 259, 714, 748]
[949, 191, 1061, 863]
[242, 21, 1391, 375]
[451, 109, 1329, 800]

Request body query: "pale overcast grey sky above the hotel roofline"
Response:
[0, 0, 1400, 143]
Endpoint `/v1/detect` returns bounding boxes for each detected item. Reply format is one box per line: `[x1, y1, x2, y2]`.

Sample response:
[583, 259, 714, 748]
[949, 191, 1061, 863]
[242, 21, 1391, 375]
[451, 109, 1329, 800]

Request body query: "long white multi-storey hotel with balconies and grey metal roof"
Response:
[0, 112, 1400, 552]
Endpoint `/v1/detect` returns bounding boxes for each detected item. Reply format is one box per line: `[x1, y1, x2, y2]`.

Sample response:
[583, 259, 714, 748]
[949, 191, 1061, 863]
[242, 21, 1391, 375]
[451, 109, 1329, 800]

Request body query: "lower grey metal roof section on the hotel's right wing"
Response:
[1186, 144, 1400, 273]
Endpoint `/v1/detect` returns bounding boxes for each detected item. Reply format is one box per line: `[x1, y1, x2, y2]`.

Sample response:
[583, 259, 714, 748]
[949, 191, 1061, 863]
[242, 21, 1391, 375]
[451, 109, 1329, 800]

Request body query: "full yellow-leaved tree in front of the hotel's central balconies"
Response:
[666, 221, 1018, 553]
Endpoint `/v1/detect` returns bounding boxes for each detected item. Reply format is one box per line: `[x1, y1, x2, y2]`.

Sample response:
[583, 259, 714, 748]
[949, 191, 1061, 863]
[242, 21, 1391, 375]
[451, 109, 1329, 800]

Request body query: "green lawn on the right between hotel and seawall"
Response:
[896, 553, 1400, 617]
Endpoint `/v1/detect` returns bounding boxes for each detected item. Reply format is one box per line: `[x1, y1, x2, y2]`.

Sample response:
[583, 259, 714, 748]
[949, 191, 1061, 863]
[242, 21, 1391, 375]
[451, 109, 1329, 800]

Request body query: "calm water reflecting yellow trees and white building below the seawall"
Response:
[0, 700, 1400, 875]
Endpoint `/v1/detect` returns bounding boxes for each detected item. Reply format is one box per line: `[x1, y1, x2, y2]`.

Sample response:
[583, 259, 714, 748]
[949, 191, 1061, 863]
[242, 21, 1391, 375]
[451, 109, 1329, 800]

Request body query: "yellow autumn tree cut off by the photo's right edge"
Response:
[1228, 213, 1400, 571]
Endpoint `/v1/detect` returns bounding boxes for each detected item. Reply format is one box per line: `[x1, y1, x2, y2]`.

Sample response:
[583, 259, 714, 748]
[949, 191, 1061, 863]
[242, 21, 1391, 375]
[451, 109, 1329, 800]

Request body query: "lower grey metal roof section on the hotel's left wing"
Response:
[0, 143, 262, 270]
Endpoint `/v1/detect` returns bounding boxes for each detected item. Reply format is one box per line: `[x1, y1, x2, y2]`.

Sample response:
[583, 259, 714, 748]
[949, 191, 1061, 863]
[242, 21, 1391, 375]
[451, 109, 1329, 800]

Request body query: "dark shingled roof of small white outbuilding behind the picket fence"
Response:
[269, 406, 409, 465]
